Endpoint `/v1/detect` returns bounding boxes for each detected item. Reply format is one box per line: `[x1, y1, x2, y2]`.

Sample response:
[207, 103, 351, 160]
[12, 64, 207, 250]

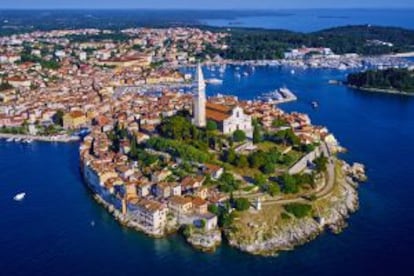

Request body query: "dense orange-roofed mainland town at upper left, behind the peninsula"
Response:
[0, 28, 225, 135]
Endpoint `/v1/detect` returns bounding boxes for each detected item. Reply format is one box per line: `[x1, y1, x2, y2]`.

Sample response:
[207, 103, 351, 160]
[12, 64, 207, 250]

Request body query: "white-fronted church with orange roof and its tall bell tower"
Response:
[193, 65, 253, 137]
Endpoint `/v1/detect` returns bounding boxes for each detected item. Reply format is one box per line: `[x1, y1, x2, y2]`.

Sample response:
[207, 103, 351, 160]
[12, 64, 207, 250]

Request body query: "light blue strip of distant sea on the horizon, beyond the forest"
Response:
[201, 9, 414, 32]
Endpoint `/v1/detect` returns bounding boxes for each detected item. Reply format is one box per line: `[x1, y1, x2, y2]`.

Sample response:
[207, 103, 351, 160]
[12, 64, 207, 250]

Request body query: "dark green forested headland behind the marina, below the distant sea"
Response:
[202, 25, 414, 60]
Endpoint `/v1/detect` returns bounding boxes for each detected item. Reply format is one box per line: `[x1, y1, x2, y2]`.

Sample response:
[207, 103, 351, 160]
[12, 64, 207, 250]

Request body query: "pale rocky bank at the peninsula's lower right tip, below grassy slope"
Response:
[225, 162, 359, 256]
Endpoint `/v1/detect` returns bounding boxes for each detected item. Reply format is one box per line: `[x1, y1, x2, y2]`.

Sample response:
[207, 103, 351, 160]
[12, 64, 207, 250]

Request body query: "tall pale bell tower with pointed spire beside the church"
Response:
[193, 64, 206, 127]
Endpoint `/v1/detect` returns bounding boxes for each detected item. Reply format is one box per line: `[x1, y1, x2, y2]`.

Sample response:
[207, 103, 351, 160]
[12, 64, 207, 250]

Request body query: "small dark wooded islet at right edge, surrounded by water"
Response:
[347, 68, 414, 96]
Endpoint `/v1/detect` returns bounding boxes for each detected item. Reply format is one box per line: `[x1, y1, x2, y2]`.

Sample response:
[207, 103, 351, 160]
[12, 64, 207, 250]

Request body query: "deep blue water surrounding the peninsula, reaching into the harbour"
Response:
[0, 67, 414, 275]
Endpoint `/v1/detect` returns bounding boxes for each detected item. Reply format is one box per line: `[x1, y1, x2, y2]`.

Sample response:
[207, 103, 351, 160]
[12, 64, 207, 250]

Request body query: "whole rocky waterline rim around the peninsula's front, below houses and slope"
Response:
[85, 153, 362, 256]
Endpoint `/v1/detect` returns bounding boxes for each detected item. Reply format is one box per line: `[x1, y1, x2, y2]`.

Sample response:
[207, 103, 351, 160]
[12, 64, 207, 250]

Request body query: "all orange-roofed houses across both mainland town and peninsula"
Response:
[0, 28, 338, 235]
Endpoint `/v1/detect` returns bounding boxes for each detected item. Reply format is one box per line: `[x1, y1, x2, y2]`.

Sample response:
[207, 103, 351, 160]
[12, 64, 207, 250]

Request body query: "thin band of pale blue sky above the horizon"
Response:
[0, 0, 414, 9]
